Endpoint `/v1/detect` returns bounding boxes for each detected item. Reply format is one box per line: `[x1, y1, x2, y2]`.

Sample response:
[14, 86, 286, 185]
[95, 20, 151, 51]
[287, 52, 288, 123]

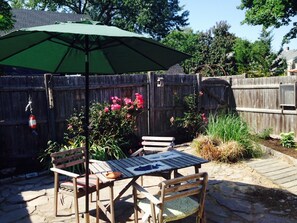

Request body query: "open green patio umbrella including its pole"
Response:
[0, 21, 190, 221]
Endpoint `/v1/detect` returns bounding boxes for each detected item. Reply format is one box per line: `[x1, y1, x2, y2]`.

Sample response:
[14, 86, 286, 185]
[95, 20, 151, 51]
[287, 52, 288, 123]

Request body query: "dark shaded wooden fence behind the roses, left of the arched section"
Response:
[0, 73, 204, 171]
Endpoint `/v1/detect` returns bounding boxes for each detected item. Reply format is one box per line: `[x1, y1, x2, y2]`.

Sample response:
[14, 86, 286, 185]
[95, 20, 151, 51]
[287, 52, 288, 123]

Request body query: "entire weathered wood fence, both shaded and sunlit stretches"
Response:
[0, 73, 297, 170]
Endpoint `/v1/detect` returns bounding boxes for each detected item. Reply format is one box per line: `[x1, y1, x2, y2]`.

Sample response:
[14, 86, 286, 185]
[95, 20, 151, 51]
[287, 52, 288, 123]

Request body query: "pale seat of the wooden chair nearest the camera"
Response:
[138, 197, 200, 222]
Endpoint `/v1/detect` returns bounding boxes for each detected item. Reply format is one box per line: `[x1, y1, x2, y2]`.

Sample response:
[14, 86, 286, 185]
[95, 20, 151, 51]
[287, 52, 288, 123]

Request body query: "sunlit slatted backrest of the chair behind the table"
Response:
[142, 136, 175, 153]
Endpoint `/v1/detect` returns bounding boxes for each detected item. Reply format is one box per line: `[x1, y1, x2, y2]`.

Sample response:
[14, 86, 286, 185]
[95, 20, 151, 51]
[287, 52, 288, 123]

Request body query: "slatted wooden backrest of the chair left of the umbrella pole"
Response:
[51, 147, 85, 169]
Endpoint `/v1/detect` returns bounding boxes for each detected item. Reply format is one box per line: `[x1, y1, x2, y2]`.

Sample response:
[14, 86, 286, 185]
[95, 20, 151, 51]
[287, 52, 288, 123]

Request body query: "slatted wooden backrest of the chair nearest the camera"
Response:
[159, 172, 208, 222]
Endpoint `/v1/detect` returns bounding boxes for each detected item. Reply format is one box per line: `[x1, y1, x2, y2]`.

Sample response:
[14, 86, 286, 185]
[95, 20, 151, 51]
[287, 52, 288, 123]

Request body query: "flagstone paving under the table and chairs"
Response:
[0, 146, 297, 223]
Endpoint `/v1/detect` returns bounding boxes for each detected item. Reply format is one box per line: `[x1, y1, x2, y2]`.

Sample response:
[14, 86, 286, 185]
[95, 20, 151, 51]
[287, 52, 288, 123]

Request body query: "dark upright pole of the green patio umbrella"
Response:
[85, 36, 90, 223]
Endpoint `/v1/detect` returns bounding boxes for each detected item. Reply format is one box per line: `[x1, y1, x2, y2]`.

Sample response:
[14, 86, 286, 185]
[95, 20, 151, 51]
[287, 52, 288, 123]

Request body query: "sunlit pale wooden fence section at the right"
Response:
[232, 76, 297, 137]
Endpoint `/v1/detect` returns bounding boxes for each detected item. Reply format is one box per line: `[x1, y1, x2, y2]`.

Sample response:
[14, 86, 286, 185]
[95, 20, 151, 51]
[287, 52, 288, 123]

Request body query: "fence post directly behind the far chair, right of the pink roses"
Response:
[147, 72, 155, 135]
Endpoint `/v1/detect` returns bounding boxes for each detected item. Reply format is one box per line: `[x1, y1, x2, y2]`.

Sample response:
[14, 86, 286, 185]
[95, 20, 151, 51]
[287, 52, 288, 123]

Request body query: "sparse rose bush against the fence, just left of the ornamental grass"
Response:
[174, 94, 207, 138]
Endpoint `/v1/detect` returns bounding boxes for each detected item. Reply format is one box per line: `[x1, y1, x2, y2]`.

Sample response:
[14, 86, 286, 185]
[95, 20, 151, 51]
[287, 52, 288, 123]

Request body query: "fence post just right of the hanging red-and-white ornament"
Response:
[44, 74, 56, 141]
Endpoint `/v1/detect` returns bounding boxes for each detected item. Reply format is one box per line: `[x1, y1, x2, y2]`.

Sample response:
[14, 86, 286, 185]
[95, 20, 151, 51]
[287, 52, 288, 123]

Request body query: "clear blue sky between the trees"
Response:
[180, 0, 297, 51]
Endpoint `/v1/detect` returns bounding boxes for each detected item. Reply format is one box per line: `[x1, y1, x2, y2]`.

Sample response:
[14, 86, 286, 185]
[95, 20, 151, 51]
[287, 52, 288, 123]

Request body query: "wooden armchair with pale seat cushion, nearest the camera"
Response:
[133, 173, 208, 223]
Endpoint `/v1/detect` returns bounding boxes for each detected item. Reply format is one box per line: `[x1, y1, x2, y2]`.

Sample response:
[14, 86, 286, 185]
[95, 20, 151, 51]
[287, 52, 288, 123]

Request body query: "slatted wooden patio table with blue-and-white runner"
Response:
[89, 150, 208, 223]
